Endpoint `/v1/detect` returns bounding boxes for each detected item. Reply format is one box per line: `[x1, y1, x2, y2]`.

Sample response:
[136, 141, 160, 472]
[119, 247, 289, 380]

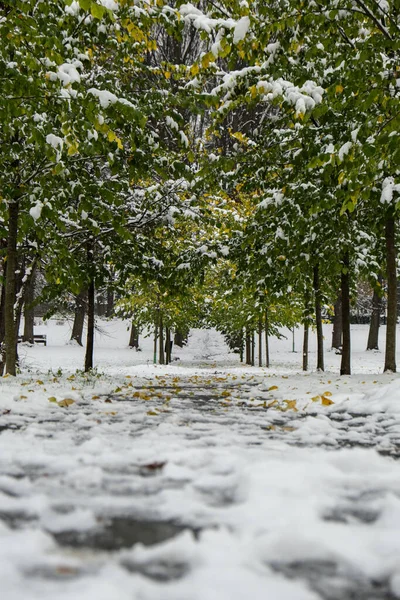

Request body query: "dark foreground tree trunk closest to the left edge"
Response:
[4, 201, 19, 375]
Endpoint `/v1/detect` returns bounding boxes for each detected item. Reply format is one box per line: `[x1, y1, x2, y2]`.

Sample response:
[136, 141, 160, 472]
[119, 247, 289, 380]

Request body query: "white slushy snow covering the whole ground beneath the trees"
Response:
[0, 320, 400, 600]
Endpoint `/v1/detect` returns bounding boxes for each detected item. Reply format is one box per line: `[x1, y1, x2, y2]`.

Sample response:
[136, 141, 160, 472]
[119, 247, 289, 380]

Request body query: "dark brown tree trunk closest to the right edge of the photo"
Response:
[384, 209, 397, 373]
